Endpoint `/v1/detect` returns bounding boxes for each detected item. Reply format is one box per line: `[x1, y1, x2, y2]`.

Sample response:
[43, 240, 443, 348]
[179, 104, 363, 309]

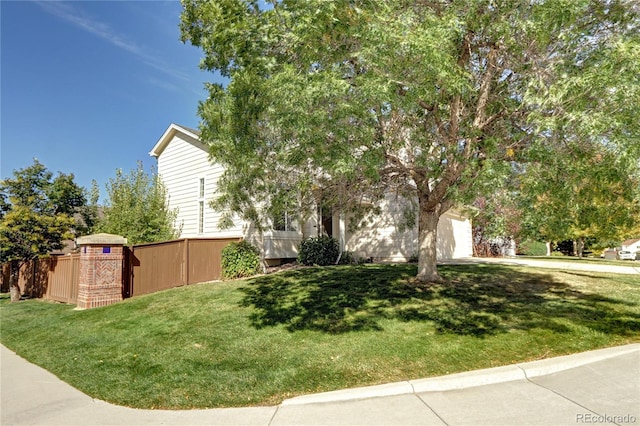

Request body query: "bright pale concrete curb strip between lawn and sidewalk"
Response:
[280, 343, 640, 406]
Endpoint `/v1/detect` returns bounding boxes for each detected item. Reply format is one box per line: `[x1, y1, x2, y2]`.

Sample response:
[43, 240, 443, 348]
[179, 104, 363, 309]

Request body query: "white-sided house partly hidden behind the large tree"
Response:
[149, 124, 473, 264]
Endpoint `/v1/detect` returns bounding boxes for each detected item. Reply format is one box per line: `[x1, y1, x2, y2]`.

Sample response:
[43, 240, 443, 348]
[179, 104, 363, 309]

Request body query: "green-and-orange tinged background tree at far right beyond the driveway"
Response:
[519, 142, 640, 256]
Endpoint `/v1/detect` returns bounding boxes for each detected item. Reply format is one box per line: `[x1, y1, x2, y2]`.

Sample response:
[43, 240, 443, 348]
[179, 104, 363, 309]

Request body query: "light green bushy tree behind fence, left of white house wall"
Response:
[97, 163, 177, 244]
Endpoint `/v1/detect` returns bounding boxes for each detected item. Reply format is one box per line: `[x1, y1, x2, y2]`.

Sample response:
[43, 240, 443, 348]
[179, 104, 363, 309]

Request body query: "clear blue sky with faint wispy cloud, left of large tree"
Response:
[0, 0, 219, 202]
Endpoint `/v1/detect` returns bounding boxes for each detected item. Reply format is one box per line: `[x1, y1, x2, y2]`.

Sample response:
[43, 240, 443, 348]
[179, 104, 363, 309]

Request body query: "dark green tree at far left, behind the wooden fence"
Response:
[0, 160, 86, 301]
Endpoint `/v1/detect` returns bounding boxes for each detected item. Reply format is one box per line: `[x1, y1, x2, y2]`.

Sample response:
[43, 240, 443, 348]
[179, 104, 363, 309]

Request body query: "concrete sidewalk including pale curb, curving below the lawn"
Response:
[0, 344, 640, 426]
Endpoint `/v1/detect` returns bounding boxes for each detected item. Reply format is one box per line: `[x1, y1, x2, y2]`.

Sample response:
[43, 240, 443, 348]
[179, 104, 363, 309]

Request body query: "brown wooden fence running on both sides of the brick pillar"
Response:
[2, 238, 239, 304]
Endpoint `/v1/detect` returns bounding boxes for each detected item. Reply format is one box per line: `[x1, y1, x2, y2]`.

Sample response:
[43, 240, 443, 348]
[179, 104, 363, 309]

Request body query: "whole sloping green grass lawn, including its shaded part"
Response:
[0, 265, 640, 409]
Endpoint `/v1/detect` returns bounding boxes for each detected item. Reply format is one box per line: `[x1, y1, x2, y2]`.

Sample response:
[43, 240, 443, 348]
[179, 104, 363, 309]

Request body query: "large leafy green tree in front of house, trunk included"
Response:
[181, 0, 640, 281]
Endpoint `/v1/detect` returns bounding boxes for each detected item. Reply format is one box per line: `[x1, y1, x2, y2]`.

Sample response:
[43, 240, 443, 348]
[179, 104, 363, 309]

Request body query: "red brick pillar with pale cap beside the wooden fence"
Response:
[76, 234, 127, 309]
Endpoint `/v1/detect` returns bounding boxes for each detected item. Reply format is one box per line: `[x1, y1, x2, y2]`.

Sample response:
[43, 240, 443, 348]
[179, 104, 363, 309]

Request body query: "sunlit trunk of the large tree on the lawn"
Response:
[416, 208, 442, 282]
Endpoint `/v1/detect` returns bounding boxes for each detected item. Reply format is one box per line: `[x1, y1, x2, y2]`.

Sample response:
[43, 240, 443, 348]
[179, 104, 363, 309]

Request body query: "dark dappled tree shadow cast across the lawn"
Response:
[242, 265, 640, 337]
